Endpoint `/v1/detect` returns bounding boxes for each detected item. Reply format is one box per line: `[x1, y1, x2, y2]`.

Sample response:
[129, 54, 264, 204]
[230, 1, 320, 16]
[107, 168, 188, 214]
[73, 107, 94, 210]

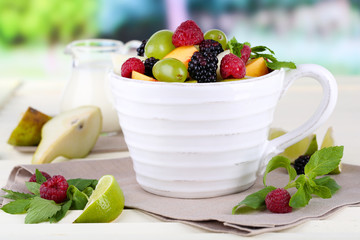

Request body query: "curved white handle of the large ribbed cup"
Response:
[258, 64, 338, 175]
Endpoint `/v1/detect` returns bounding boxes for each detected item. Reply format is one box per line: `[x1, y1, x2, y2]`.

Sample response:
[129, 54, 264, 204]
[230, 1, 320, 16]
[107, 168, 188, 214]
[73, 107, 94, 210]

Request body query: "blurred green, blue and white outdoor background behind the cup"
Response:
[0, 0, 360, 80]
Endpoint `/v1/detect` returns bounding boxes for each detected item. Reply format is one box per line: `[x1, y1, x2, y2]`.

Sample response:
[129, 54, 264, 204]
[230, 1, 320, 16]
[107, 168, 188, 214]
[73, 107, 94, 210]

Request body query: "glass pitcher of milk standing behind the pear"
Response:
[60, 39, 141, 133]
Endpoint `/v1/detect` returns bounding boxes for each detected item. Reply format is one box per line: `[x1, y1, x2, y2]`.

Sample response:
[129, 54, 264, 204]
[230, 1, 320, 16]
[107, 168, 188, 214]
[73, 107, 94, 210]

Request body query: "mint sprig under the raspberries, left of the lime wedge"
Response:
[0, 169, 98, 223]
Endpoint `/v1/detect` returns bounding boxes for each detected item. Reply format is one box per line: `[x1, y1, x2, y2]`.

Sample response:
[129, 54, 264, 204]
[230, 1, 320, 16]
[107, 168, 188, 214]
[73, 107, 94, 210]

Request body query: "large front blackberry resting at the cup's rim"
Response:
[188, 52, 218, 83]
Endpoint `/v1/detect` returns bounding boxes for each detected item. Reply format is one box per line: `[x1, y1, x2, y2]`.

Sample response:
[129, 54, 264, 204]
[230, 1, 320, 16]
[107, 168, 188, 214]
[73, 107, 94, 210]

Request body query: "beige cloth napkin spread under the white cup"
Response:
[0, 158, 360, 236]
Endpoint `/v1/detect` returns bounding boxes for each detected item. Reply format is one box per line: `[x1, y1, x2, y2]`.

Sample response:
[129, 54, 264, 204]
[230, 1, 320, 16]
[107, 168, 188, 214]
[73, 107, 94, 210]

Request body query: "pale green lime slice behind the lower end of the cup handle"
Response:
[269, 128, 314, 163]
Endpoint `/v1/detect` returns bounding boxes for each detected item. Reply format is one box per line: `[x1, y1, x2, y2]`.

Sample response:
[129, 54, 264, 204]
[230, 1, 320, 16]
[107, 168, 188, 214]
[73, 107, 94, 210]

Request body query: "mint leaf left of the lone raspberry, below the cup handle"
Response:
[232, 186, 276, 214]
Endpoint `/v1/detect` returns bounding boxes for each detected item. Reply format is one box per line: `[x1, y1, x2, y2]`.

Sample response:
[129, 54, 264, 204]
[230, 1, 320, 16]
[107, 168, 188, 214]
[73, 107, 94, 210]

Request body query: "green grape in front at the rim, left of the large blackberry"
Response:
[153, 58, 188, 82]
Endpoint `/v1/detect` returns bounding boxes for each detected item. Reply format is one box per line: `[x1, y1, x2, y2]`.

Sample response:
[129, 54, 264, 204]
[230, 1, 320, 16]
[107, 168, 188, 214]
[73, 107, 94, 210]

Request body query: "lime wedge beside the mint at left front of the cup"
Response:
[74, 175, 125, 223]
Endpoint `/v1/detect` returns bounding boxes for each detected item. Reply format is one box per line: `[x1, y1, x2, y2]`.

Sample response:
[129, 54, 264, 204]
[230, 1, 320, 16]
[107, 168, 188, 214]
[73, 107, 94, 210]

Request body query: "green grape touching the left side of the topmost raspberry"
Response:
[145, 30, 175, 59]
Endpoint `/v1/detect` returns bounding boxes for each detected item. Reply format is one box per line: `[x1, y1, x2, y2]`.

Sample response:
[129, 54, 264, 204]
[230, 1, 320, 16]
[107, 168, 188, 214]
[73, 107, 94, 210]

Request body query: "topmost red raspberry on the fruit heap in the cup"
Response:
[172, 20, 204, 47]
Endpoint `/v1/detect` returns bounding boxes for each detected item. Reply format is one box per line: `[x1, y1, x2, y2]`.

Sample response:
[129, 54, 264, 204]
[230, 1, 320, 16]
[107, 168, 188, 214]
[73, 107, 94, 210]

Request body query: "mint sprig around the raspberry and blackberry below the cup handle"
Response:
[232, 145, 344, 214]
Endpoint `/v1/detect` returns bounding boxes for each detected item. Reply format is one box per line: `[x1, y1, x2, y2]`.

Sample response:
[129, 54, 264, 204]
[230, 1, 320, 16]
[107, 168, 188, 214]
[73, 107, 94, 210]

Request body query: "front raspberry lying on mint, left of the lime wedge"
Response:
[40, 175, 69, 203]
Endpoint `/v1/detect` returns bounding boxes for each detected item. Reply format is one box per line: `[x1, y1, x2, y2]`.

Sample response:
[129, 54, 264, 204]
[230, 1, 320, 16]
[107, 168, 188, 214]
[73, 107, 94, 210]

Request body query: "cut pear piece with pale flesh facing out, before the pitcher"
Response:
[32, 106, 102, 164]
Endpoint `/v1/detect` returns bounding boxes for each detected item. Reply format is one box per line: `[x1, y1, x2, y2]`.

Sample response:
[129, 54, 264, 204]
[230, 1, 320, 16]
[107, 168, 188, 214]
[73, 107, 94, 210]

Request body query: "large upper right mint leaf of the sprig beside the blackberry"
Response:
[304, 146, 344, 178]
